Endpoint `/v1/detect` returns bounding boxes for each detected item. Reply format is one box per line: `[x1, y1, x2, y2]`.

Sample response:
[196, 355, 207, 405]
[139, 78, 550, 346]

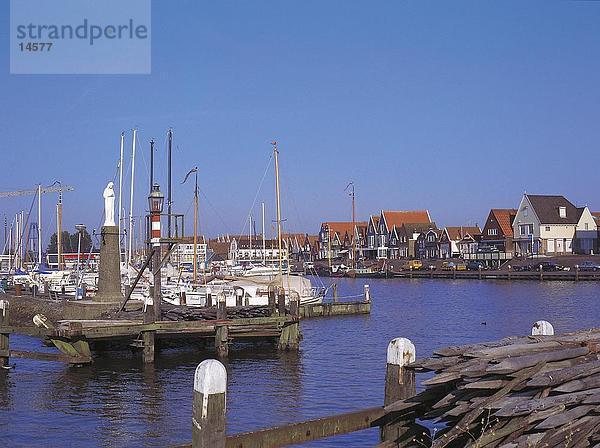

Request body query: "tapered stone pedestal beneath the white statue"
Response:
[94, 226, 124, 302]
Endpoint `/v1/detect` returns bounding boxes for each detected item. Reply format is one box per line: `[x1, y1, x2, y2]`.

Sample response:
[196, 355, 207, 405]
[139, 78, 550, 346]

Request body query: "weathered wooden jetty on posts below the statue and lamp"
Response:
[0, 300, 302, 365]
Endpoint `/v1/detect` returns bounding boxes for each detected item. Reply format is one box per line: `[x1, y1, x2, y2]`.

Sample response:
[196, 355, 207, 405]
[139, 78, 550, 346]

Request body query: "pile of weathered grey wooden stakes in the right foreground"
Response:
[386, 330, 600, 448]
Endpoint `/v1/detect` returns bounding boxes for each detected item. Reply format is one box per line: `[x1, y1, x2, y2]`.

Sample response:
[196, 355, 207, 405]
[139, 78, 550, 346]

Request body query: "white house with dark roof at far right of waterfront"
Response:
[513, 194, 597, 255]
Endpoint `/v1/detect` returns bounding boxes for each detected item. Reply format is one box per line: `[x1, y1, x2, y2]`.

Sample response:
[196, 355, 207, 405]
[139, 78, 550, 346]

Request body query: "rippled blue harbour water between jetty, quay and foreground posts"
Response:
[0, 279, 600, 447]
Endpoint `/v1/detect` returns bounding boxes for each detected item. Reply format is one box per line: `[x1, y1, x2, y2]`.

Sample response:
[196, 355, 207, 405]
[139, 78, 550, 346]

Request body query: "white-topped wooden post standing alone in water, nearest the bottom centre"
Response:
[192, 359, 227, 448]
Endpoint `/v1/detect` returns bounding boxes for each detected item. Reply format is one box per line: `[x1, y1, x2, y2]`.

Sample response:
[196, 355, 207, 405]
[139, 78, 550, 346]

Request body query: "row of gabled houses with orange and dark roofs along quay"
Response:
[317, 194, 600, 260]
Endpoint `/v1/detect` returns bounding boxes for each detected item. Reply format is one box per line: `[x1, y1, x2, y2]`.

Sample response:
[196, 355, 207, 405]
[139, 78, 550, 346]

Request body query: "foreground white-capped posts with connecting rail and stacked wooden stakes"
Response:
[180, 321, 600, 448]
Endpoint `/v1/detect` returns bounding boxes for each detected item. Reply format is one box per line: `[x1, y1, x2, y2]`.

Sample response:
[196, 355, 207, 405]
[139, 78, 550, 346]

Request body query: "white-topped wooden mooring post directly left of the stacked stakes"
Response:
[381, 338, 417, 441]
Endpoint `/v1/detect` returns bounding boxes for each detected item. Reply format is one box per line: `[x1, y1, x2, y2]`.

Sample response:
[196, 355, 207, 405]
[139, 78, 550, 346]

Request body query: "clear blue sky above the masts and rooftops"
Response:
[0, 0, 600, 247]
